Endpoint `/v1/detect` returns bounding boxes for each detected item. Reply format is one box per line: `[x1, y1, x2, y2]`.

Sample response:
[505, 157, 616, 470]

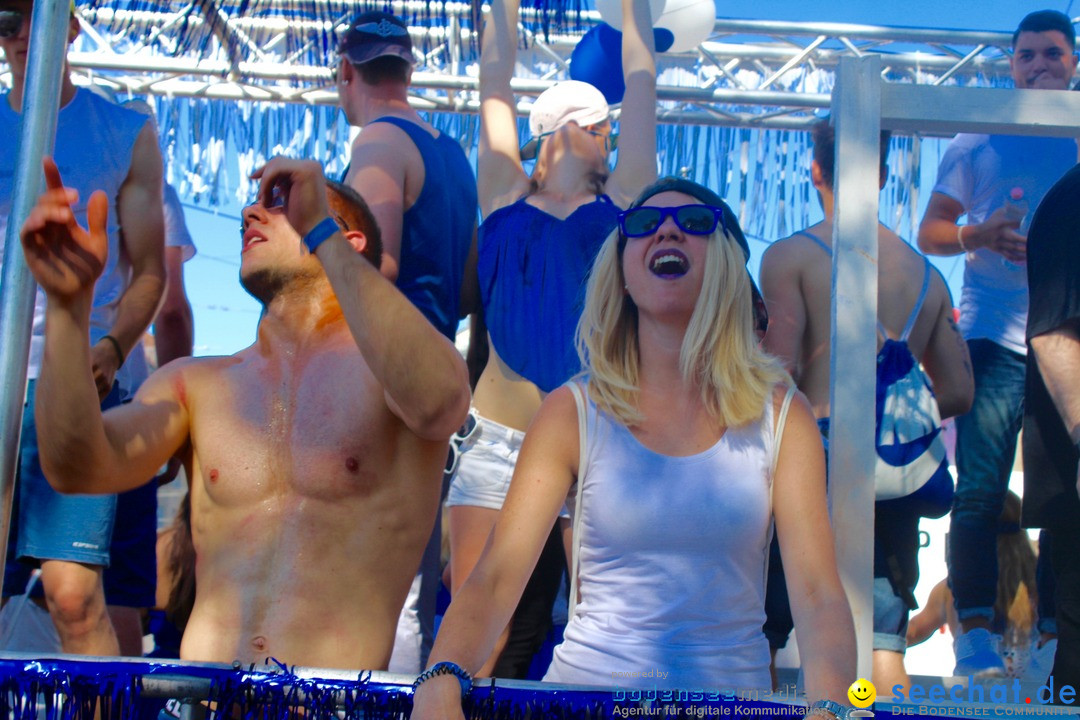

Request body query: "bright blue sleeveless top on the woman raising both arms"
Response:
[476, 195, 619, 393]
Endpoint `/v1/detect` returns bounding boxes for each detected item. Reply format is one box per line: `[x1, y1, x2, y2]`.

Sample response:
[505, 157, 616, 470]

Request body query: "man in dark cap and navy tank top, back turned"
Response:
[335, 12, 476, 674]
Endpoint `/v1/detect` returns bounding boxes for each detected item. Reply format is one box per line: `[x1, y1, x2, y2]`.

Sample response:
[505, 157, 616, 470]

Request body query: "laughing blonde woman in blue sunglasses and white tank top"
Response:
[413, 178, 855, 719]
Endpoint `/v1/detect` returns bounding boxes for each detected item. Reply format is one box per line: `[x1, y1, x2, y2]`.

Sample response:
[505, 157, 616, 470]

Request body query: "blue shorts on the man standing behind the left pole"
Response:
[3, 380, 121, 597]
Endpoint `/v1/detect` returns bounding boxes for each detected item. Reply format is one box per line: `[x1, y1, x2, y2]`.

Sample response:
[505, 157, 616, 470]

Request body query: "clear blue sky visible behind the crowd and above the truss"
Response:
[172, 0, 1080, 355]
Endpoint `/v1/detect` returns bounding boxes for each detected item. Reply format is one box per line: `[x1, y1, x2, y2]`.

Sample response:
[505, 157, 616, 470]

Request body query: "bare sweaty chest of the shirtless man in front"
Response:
[191, 361, 396, 507]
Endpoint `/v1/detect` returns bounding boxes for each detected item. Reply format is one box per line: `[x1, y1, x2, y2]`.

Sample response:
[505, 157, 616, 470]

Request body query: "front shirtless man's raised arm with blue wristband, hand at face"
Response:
[253, 158, 470, 440]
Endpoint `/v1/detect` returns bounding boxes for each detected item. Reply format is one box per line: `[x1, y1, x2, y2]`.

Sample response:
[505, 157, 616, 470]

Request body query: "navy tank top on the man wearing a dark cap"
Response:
[372, 118, 476, 340]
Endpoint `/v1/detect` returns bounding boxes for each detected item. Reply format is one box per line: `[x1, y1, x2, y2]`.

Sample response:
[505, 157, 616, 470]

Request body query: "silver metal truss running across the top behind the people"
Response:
[0, 0, 1028, 128]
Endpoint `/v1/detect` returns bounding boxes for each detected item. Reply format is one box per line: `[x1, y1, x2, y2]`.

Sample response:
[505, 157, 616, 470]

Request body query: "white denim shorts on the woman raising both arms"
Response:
[446, 416, 525, 510]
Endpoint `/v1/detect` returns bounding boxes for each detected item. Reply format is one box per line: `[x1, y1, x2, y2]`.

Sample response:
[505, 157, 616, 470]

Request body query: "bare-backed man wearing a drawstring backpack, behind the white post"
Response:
[761, 120, 974, 688]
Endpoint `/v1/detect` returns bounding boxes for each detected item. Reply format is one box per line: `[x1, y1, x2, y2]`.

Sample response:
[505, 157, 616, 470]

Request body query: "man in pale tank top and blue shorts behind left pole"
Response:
[0, 0, 165, 655]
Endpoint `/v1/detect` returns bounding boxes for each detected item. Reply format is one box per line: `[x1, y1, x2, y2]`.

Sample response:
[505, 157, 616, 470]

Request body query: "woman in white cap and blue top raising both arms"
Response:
[446, 0, 657, 676]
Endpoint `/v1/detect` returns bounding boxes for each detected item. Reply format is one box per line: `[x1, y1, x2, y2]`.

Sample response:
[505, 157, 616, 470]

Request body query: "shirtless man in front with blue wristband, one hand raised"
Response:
[22, 158, 469, 669]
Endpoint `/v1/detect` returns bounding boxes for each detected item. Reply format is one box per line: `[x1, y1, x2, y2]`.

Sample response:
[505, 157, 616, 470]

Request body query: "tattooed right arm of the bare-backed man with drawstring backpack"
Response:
[919, 270, 975, 420]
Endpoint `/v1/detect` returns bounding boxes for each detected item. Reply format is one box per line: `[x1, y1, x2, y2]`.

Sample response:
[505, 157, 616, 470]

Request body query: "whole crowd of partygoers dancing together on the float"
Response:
[0, 0, 1080, 718]
